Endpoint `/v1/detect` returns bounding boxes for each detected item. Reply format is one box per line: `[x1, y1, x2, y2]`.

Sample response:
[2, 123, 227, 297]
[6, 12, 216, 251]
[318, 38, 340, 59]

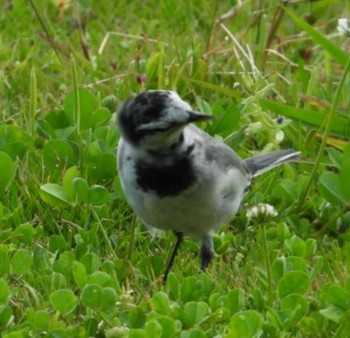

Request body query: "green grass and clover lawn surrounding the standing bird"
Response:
[0, 0, 350, 338]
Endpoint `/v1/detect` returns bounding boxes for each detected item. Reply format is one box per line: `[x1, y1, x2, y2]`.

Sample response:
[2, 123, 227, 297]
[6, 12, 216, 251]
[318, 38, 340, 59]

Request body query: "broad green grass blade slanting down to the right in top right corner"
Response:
[284, 7, 348, 67]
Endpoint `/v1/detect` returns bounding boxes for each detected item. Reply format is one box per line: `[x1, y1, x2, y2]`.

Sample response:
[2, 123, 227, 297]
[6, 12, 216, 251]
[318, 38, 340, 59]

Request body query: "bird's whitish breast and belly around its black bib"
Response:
[118, 128, 250, 235]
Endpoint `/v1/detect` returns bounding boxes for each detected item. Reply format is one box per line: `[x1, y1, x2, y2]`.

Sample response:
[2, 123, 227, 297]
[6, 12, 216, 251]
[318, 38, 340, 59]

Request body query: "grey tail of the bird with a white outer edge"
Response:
[245, 149, 300, 177]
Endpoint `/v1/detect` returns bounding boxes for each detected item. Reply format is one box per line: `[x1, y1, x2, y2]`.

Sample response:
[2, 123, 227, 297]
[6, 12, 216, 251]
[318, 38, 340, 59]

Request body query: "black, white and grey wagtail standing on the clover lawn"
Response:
[118, 90, 299, 281]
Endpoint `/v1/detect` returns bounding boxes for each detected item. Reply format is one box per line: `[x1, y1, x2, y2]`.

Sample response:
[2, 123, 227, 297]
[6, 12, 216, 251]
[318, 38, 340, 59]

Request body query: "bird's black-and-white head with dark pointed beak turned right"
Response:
[118, 90, 212, 151]
